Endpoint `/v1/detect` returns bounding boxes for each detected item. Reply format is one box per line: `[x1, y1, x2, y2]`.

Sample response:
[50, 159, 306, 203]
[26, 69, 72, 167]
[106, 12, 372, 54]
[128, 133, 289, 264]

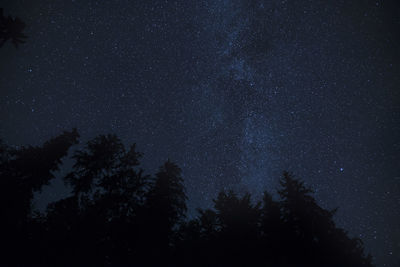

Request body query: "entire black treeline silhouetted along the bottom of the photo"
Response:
[0, 130, 372, 266]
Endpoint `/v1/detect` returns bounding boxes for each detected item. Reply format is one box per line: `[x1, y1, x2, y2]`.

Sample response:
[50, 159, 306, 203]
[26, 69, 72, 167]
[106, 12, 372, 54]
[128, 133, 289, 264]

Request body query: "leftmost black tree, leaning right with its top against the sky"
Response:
[0, 129, 79, 264]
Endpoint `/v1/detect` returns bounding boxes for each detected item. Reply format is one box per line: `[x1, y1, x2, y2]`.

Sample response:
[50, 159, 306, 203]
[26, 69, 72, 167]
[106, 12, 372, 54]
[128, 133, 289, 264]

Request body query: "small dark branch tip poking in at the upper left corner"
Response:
[0, 8, 28, 48]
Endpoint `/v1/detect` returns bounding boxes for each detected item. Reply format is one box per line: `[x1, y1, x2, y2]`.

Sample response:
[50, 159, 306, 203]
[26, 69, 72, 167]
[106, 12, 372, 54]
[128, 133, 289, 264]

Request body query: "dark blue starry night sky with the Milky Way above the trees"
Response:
[0, 0, 400, 266]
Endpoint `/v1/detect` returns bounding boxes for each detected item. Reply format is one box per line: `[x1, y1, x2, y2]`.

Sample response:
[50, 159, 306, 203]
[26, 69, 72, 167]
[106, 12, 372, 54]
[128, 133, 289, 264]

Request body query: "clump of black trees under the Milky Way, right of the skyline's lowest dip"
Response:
[178, 172, 372, 266]
